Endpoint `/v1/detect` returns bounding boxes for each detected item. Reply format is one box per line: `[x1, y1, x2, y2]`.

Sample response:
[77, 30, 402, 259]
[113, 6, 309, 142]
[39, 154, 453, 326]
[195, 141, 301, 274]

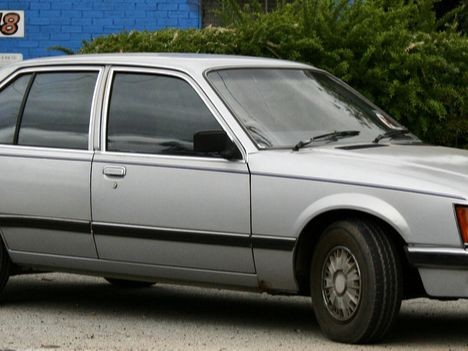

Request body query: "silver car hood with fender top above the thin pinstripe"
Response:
[249, 144, 468, 200]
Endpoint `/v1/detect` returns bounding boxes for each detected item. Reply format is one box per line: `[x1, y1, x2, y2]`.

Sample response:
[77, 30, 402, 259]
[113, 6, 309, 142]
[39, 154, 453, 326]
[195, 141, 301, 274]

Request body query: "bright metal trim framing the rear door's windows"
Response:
[0, 65, 105, 151]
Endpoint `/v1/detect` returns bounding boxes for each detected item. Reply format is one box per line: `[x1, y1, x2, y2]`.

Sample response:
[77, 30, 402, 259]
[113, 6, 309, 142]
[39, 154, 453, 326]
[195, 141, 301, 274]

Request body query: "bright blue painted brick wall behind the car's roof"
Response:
[0, 0, 201, 59]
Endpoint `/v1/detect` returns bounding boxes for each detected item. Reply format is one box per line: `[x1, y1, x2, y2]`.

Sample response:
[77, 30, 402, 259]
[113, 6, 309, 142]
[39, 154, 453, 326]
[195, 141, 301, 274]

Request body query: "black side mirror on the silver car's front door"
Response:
[193, 130, 242, 160]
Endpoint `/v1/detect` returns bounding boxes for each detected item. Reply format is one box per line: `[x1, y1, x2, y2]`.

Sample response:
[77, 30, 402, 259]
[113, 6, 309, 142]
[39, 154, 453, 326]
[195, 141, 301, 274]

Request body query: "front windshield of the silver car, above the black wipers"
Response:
[208, 68, 414, 149]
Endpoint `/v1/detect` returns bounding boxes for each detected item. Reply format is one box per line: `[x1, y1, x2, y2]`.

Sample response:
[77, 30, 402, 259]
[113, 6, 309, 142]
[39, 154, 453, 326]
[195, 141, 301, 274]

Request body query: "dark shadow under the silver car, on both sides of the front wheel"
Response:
[1, 274, 468, 349]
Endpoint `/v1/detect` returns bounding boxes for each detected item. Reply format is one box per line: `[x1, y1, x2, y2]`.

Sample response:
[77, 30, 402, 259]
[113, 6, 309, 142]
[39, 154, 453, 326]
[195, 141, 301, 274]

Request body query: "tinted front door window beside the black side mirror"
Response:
[107, 73, 222, 156]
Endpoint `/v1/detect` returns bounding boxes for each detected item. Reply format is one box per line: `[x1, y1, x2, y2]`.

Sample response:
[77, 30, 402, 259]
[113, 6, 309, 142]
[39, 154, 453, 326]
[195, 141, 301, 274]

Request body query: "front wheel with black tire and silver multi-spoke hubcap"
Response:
[310, 219, 403, 344]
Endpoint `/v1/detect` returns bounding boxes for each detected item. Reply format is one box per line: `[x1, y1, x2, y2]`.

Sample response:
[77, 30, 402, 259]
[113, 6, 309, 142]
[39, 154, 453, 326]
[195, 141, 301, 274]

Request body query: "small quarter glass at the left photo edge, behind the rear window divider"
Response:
[0, 74, 31, 144]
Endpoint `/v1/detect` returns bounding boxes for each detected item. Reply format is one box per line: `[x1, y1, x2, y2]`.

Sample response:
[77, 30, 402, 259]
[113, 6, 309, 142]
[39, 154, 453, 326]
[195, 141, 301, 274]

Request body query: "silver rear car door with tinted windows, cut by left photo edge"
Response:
[0, 67, 102, 257]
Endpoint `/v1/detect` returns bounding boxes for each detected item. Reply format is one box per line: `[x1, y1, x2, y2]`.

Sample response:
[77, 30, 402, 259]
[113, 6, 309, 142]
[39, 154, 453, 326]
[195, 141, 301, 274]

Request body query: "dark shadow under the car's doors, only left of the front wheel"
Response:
[1, 274, 320, 333]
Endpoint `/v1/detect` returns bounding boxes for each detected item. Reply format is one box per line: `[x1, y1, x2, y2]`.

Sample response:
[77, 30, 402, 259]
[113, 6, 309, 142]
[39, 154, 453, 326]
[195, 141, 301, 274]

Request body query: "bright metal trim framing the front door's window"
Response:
[100, 66, 247, 164]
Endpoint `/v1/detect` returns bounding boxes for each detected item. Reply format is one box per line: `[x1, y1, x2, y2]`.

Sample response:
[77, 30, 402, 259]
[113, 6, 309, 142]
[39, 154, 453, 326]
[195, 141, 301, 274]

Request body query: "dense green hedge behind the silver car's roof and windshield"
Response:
[81, 0, 468, 148]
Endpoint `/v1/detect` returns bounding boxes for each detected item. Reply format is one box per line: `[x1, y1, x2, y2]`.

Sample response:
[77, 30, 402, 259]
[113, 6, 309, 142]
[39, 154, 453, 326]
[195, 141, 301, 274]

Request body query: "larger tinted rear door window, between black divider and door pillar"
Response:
[18, 72, 98, 149]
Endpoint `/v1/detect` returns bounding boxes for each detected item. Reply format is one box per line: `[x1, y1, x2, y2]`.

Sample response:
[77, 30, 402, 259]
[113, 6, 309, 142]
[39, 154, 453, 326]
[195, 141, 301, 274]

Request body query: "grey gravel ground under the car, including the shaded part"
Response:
[0, 273, 468, 351]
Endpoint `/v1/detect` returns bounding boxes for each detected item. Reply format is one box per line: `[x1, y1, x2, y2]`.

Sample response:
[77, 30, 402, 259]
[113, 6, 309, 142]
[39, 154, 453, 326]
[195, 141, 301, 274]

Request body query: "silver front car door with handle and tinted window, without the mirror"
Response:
[92, 68, 255, 273]
